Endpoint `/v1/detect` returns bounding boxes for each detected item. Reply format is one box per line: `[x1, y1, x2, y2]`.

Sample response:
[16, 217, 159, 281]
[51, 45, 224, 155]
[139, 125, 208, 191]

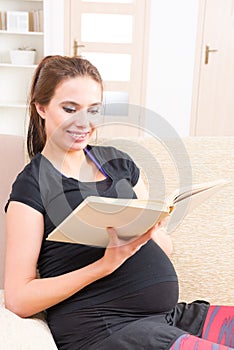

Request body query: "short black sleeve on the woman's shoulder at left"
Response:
[5, 167, 45, 214]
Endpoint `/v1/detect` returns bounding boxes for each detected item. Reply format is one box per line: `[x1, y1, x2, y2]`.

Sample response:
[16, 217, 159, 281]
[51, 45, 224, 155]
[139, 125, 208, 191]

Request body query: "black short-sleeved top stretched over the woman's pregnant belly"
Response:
[6, 146, 177, 313]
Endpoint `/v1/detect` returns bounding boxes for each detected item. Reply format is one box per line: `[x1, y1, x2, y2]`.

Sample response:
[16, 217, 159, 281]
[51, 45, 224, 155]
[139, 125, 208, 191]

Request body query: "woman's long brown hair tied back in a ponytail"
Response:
[27, 55, 103, 158]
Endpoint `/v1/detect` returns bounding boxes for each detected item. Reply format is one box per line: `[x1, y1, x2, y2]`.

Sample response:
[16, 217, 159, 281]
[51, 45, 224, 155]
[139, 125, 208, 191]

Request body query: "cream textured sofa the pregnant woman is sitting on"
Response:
[0, 135, 234, 350]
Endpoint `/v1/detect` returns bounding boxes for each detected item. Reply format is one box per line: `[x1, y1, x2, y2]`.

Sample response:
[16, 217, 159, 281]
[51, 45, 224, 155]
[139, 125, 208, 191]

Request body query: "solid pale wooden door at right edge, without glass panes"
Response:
[191, 0, 234, 136]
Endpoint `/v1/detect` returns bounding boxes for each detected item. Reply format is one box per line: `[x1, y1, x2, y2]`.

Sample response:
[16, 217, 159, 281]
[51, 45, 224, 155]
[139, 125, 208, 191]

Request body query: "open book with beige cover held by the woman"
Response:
[47, 181, 228, 247]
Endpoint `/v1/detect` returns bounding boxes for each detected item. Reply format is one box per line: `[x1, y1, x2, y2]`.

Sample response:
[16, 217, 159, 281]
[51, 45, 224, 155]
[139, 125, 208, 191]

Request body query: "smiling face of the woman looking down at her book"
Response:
[36, 77, 102, 151]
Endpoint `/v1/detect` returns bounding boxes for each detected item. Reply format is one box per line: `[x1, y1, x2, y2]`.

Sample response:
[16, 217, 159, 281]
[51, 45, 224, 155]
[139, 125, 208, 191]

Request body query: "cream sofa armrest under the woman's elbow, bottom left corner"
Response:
[0, 290, 57, 350]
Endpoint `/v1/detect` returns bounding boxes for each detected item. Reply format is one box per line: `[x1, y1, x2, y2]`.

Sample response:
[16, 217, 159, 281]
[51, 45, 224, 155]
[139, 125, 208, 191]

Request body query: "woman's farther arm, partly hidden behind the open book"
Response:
[133, 177, 173, 256]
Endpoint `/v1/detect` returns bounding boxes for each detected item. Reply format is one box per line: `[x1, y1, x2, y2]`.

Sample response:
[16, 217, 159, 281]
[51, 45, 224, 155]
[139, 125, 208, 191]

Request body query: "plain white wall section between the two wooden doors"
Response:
[146, 0, 198, 136]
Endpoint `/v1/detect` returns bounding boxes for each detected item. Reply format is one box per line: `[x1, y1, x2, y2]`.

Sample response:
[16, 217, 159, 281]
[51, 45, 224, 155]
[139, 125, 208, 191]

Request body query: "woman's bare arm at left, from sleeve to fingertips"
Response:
[5, 202, 153, 317]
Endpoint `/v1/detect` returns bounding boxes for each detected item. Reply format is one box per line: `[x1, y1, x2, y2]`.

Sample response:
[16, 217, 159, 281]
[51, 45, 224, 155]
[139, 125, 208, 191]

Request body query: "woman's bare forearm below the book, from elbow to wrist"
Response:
[5, 259, 109, 317]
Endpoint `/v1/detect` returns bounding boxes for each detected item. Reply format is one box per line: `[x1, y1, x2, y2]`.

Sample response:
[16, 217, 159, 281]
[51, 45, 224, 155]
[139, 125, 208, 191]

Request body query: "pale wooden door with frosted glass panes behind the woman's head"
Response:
[65, 0, 150, 137]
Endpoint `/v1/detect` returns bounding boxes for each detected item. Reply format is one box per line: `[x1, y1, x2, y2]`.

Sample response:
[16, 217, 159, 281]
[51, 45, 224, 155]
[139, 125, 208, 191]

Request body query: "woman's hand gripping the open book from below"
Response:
[102, 225, 157, 273]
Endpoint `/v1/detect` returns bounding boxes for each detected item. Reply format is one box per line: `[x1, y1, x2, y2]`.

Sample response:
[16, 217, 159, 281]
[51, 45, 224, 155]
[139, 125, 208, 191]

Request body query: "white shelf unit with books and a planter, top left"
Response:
[0, 0, 45, 135]
